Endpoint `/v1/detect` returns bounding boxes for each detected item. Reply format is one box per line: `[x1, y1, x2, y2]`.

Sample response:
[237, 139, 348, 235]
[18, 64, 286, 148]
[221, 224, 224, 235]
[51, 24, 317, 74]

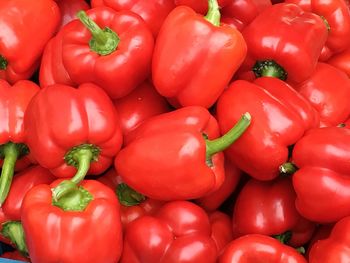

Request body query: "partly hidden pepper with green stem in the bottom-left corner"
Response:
[0, 166, 55, 255]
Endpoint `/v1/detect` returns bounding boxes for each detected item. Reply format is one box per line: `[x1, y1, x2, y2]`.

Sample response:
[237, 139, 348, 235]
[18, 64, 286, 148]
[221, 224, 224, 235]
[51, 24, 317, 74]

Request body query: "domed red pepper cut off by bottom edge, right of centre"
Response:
[218, 235, 307, 263]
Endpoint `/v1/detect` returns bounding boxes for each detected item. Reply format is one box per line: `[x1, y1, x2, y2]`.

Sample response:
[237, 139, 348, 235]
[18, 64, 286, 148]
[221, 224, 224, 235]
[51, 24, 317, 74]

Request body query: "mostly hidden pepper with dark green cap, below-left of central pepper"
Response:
[98, 169, 164, 229]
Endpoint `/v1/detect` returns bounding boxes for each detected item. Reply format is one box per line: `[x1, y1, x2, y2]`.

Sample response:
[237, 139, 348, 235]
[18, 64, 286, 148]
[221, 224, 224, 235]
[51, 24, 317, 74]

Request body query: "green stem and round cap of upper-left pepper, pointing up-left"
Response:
[77, 11, 120, 56]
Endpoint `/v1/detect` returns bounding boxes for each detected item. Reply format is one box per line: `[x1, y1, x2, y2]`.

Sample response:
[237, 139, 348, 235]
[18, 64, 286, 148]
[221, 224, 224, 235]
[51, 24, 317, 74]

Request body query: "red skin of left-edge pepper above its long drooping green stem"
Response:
[0, 79, 40, 171]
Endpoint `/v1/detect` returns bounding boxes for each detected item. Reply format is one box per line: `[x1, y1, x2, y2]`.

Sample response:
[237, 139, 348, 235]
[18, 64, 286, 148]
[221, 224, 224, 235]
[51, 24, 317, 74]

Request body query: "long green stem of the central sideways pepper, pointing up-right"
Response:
[205, 112, 251, 164]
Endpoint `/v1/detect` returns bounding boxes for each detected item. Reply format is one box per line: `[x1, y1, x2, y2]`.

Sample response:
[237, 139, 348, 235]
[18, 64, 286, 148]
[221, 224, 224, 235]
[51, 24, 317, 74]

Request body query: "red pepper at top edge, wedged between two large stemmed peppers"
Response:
[91, 0, 175, 37]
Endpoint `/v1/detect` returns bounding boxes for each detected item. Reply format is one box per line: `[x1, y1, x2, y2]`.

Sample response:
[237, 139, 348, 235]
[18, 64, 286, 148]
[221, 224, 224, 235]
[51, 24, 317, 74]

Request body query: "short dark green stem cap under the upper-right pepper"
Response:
[253, 60, 287, 80]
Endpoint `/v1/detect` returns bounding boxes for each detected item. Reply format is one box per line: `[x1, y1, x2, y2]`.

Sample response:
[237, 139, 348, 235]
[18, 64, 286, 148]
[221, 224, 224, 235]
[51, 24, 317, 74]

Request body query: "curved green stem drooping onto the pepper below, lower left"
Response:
[52, 144, 100, 210]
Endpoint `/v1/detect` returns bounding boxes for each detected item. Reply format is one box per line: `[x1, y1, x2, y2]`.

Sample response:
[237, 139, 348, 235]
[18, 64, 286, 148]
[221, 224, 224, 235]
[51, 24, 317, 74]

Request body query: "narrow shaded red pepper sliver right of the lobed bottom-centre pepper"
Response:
[209, 211, 233, 253]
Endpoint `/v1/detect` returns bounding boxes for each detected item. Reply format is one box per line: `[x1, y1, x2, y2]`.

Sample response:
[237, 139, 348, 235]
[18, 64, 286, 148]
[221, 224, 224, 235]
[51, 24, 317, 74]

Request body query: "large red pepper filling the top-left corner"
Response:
[0, 0, 61, 84]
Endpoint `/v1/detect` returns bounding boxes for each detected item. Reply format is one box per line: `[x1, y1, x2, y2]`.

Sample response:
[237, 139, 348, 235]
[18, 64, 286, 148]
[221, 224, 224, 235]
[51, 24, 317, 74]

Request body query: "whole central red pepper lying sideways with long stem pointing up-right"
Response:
[115, 106, 250, 201]
